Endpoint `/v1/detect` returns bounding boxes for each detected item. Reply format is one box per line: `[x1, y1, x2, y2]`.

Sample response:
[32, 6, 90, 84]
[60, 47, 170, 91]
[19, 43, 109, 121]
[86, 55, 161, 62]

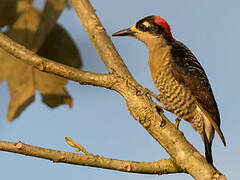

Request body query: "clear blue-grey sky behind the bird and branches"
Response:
[0, 0, 240, 180]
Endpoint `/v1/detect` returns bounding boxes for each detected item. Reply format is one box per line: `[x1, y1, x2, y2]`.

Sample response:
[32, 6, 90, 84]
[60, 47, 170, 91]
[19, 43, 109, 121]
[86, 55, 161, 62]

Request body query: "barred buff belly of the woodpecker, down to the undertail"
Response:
[154, 69, 214, 142]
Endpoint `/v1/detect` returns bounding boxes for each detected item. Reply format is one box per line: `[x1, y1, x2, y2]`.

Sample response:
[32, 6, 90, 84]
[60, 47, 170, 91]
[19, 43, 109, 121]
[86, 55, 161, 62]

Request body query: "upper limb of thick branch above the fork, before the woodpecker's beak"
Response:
[71, 0, 132, 79]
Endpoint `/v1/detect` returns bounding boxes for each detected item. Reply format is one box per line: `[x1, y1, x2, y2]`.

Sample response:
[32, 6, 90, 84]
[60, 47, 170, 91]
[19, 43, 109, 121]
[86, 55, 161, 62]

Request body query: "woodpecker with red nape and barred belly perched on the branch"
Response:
[113, 16, 226, 164]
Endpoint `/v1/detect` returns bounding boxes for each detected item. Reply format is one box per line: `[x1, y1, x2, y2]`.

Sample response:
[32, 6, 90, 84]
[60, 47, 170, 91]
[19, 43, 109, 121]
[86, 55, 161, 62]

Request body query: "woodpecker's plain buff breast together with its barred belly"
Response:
[149, 45, 196, 121]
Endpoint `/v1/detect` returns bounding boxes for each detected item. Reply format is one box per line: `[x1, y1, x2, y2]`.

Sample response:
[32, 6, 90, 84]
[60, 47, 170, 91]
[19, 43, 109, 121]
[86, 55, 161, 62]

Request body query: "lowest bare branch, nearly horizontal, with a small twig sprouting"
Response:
[0, 141, 182, 174]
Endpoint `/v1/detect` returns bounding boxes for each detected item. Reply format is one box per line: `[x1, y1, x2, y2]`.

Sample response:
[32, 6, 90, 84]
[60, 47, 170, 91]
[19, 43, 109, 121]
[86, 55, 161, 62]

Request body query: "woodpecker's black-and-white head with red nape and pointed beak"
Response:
[112, 16, 173, 45]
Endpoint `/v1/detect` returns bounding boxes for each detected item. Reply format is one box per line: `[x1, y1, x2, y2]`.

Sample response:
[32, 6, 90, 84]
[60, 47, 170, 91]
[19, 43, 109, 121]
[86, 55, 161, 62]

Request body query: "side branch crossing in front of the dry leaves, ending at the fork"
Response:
[0, 33, 114, 88]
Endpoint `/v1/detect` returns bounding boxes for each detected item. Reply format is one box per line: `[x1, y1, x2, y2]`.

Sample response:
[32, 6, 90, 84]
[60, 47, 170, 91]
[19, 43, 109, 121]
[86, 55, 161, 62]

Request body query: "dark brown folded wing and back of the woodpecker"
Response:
[171, 41, 226, 145]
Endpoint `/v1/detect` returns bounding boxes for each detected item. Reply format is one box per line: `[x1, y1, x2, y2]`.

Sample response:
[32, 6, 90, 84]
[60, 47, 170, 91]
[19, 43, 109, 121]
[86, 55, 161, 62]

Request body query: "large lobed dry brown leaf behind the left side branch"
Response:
[0, 5, 81, 121]
